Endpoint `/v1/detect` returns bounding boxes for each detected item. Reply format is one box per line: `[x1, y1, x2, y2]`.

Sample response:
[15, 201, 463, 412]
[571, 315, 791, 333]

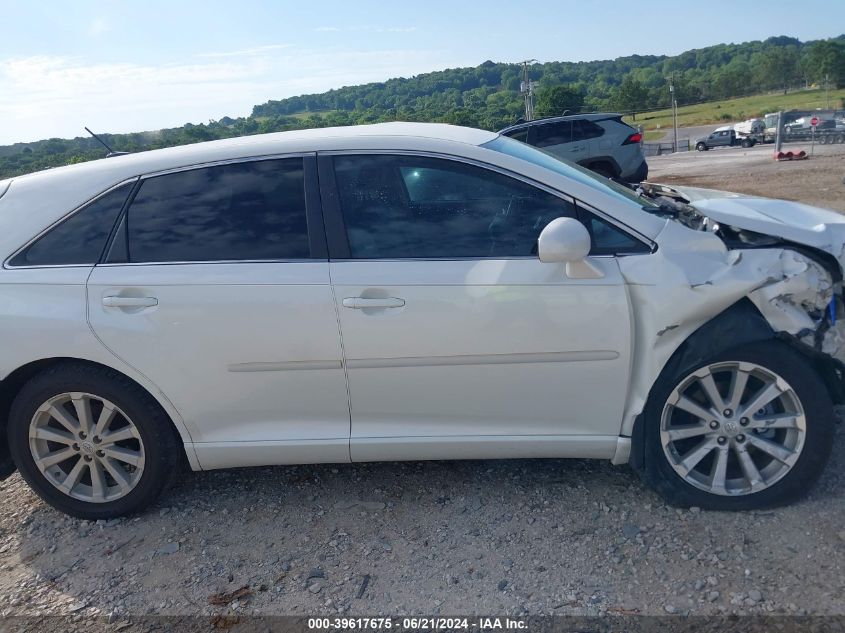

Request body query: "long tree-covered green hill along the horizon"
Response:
[0, 35, 845, 178]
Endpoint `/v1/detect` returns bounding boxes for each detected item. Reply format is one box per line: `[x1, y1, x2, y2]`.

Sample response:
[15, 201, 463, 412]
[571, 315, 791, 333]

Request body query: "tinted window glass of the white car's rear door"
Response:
[122, 158, 309, 262]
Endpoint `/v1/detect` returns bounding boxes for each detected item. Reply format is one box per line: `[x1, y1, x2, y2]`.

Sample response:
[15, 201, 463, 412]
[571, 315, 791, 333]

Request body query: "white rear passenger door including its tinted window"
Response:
[88, 156, 349, 468]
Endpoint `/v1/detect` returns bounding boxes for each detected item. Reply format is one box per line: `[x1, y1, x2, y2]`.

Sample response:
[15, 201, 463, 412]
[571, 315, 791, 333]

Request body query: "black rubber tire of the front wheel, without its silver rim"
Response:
[642, 340, 834, 510]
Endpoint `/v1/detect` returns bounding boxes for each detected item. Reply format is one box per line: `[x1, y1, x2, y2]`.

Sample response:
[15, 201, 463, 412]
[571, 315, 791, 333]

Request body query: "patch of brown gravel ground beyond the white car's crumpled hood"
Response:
[648, 135, 845, 212]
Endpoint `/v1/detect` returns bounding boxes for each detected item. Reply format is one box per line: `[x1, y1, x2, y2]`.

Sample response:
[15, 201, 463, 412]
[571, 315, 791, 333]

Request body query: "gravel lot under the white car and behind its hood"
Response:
[0, 137, 845, 630]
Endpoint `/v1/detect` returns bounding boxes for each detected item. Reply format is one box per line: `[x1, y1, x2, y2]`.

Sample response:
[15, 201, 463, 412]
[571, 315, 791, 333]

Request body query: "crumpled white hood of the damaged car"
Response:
[666, 186, 845, 267]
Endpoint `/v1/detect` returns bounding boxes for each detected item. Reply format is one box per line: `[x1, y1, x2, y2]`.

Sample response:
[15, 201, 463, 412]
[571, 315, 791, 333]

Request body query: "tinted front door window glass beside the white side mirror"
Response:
[334, 156, 575, 259]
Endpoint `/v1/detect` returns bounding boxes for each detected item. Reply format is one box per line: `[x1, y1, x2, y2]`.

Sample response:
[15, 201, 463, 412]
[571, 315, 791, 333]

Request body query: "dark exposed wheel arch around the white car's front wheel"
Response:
[628, 297, 845, 470]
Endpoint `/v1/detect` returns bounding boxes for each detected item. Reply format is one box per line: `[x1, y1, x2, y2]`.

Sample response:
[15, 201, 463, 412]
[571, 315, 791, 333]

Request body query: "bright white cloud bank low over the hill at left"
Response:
[0, 44, 468, 144]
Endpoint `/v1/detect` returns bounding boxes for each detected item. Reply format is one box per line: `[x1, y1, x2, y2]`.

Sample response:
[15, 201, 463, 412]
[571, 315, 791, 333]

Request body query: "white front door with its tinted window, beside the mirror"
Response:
[320, 154, 631, 461]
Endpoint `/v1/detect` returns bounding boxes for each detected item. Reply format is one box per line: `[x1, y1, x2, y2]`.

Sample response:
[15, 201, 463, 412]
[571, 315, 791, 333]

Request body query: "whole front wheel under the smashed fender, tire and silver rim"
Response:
[645, 341, 834, 510]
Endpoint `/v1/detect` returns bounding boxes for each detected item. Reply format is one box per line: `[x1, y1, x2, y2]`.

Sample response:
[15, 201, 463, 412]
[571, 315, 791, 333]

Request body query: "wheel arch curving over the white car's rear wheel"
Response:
[0, 356, 199, 479]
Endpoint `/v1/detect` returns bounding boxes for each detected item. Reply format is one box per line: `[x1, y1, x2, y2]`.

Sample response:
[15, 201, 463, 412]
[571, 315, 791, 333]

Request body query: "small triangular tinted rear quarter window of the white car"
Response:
[9, 183, 134, 266]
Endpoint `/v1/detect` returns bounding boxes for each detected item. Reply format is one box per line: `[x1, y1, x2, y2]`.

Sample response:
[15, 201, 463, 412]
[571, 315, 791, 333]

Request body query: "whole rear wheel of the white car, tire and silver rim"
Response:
[9, 364, 178, 519]
